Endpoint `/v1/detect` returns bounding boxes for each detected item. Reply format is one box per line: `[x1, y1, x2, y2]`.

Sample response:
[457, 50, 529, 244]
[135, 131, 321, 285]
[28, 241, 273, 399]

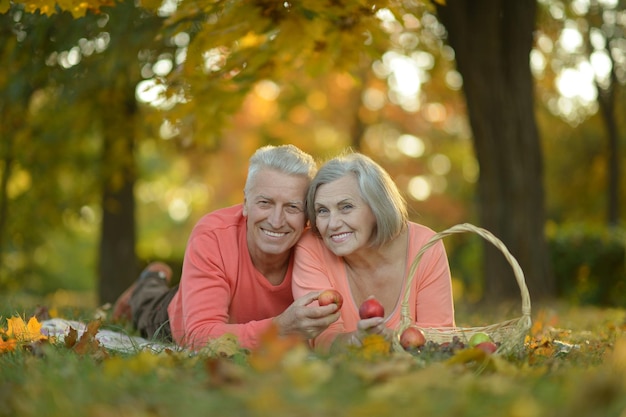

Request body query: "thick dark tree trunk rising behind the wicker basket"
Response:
[437, 0, 555, 300]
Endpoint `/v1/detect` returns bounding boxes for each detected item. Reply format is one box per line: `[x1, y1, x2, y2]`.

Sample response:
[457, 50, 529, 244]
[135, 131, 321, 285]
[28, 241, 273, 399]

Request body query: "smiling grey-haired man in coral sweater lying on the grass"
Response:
[113, 145, 339, 349]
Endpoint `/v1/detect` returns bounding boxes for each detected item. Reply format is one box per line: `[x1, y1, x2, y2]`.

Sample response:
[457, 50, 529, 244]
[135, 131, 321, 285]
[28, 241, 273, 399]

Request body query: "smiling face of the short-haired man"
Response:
[243, 169, 309, 259]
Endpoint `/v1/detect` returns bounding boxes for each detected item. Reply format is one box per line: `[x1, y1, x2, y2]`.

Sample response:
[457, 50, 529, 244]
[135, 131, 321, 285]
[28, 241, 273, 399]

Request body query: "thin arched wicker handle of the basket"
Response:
[401, 223, 530, 327]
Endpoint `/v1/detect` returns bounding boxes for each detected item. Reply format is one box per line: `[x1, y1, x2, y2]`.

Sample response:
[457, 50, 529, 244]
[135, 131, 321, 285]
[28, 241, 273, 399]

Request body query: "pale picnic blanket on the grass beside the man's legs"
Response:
[41, 318, 173, 353]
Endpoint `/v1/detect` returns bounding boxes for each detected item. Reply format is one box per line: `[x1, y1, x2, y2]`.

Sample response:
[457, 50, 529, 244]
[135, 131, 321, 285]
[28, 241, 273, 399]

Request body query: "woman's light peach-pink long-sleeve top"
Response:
[293, 223, 454, 351]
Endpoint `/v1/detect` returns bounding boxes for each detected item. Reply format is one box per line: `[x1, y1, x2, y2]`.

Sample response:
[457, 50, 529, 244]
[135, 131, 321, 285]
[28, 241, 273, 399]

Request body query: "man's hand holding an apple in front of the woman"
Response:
[274, 291, 340, 339]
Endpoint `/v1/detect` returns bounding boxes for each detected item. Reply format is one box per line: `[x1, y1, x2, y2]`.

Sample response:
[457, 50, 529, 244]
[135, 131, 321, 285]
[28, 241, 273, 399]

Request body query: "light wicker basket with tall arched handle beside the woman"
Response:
[393, 223, 531, 354]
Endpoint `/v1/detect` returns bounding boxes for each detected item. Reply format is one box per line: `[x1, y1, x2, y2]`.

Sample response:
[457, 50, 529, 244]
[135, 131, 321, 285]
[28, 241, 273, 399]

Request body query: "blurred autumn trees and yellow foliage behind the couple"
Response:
[0, 0, 626, 314]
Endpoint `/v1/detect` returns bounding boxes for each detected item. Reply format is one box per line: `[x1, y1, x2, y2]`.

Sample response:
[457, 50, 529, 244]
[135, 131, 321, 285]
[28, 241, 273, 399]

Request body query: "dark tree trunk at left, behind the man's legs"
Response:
[98, 96, 138, 303]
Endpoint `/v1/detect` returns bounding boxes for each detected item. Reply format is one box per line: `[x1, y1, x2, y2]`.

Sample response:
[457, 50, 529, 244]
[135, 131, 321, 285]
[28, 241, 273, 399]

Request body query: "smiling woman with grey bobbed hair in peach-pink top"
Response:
[293, 153, 454, 352]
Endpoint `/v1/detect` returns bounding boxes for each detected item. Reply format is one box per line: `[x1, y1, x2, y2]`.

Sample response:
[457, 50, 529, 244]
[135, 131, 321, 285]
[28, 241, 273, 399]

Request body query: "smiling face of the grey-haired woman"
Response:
[315, 174, 376, 256]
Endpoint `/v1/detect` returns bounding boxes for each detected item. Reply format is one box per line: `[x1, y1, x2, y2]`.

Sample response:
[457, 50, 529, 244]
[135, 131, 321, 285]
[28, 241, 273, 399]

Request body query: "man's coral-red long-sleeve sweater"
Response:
[168, 204, 293, 349]
